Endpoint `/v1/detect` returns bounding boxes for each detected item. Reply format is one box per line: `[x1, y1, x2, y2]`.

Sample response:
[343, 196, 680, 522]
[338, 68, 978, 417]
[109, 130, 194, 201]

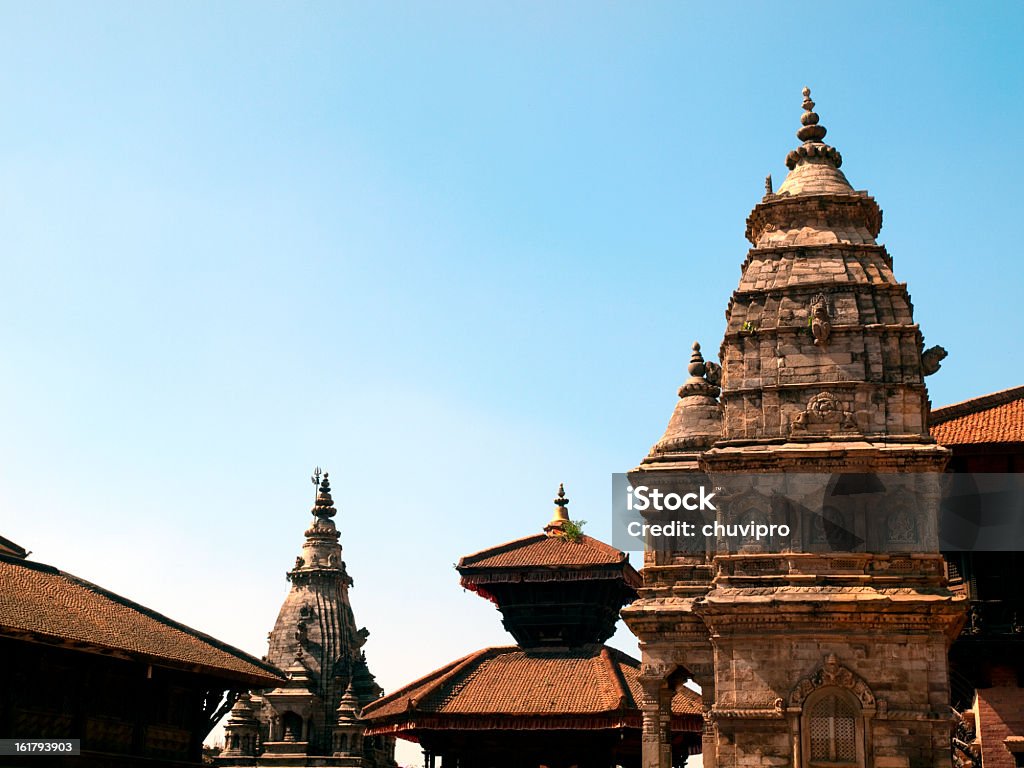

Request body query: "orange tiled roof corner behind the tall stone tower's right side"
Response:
[929, 386, 1024, 445]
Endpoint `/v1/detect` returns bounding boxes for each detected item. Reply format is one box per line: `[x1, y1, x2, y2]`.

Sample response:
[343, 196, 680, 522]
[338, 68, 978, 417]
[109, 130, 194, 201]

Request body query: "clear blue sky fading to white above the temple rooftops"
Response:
[0, 0, 1024, 765]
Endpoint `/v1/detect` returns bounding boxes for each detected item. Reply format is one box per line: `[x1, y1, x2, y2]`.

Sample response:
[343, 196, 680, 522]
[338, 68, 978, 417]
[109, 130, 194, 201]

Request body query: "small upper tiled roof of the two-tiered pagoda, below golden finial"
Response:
[457, 534, 628, 569]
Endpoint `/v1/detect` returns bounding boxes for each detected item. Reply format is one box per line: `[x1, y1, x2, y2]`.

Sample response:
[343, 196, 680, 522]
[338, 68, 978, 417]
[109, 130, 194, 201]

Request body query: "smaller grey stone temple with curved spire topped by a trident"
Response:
[218, 470, 396, 768]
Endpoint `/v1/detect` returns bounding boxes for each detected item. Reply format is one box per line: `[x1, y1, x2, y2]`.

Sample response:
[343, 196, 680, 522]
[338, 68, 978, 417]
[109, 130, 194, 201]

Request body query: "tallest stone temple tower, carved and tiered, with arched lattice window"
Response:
[623, 89, 964, 768]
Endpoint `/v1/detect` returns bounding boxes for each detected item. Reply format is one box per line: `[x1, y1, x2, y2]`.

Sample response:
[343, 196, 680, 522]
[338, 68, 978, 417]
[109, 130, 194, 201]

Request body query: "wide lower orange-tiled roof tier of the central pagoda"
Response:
[362, 645, 700, 732]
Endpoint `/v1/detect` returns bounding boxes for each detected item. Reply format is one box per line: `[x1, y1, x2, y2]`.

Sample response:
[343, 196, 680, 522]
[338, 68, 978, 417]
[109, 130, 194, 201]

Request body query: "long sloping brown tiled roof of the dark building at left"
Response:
[0, 556, 284, 687]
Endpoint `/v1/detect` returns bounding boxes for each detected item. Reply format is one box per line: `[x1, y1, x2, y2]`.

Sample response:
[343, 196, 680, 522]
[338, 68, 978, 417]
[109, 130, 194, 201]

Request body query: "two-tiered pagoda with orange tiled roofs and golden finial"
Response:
[362, 487, 702, 768]
